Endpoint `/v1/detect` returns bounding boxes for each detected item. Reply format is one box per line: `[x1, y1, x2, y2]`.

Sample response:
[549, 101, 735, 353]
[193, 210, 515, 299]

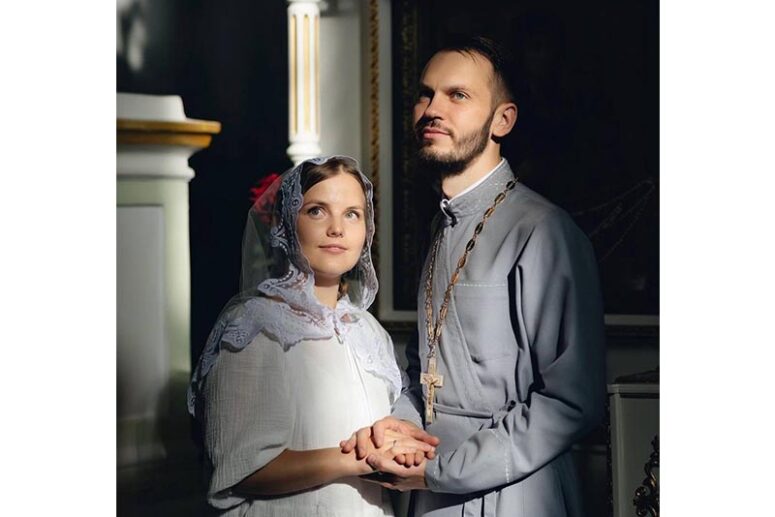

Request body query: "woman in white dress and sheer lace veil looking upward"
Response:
[189, 157, 431, 517]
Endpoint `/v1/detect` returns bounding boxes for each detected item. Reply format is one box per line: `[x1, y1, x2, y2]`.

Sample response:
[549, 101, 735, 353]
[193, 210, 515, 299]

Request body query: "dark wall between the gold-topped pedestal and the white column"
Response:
[117, 0, 291, 357]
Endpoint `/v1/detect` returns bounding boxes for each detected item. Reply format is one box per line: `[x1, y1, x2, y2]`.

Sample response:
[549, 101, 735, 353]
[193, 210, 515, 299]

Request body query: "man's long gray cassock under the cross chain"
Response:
[393, 160, 605, 517]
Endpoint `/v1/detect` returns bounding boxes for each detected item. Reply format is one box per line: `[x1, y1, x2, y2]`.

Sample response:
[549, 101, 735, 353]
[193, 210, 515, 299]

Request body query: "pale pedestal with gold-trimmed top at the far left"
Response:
[116, 93, 220, 512]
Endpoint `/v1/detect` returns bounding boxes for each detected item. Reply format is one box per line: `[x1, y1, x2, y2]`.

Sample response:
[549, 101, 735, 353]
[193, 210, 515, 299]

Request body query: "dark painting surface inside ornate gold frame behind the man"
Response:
[392, 0, 659, 316]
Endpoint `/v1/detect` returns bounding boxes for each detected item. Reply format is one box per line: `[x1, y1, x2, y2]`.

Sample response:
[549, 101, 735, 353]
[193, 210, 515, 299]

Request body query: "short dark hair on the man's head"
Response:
[436, 36, 517, 104]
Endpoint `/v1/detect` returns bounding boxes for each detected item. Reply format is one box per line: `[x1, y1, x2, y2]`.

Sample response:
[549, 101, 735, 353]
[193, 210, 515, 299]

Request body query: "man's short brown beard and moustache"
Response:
[415, 112, 495, 179]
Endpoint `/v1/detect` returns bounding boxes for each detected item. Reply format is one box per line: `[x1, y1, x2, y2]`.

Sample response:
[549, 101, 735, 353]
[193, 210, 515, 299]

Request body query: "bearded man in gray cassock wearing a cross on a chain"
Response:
[343, 38, 605, 517]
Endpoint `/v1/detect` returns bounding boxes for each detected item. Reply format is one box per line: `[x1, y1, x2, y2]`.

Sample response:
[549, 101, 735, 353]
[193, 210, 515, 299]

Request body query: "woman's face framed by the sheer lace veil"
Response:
[297, 172, 366, 285]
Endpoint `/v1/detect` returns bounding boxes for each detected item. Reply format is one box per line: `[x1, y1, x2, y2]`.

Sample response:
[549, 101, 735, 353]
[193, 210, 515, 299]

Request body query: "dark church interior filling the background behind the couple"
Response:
[116, 0, 660, 517]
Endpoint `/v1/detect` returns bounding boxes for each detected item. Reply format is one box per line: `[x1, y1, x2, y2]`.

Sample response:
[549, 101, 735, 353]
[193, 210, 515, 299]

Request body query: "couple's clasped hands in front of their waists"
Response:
[339, 416, 439, 492]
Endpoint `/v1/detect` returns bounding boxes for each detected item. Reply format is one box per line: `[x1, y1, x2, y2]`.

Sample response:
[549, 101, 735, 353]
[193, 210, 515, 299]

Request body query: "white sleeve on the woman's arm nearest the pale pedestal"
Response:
[204, 334, 293, 508]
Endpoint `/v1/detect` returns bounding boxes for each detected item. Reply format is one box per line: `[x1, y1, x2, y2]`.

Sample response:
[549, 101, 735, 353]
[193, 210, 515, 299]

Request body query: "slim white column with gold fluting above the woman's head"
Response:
[287, 0, 321, 165]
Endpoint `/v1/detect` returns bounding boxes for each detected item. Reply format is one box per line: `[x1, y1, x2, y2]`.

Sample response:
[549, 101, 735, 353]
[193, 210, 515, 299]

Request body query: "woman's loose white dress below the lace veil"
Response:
[204, 311, 394, 517]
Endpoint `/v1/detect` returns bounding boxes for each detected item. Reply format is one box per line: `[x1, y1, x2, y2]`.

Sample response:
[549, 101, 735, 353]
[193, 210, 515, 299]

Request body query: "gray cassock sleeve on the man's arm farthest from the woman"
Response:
[425, 211, 605, 493]
